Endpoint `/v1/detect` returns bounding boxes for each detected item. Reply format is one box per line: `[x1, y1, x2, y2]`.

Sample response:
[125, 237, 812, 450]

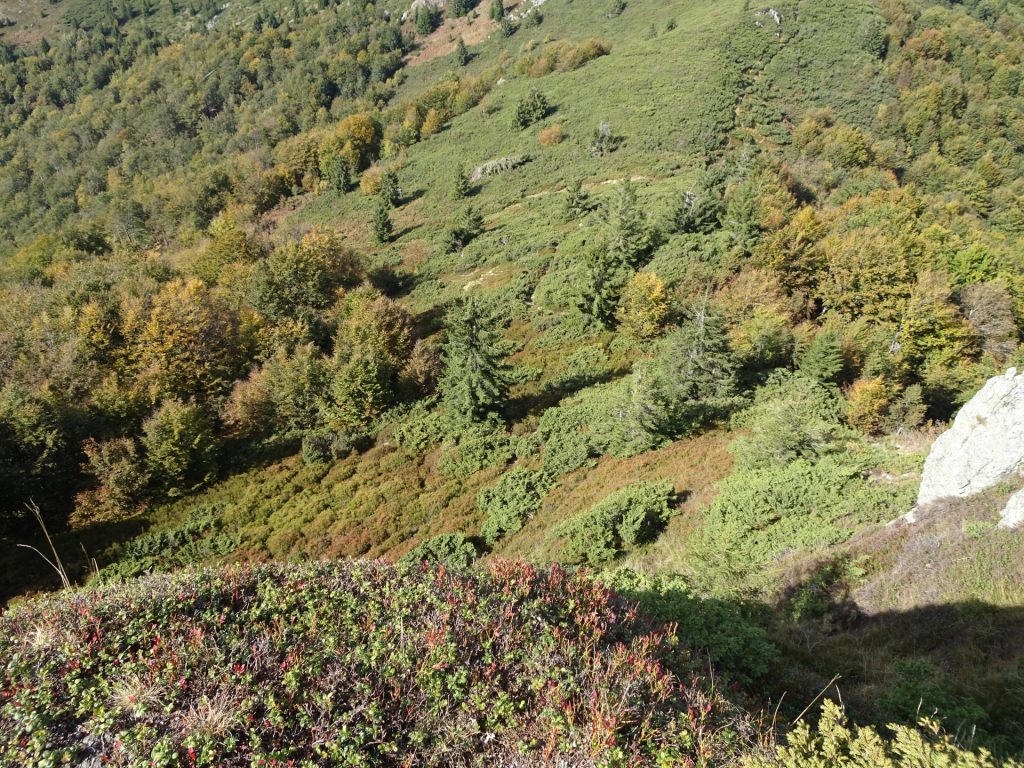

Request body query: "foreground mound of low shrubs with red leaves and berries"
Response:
[0, 561, 753, 768]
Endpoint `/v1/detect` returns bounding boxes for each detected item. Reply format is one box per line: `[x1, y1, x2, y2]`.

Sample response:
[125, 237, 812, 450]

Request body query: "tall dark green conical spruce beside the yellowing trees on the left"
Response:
[439, 297, 509, 421]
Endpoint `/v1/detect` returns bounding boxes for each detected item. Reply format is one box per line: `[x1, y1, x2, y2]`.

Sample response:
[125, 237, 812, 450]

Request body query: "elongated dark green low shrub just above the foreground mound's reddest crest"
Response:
[559, 480, 675, 565]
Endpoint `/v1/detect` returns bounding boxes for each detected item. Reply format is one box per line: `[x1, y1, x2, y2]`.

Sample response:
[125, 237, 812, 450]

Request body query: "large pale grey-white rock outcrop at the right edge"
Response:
[907, 368, 1024, 524]
